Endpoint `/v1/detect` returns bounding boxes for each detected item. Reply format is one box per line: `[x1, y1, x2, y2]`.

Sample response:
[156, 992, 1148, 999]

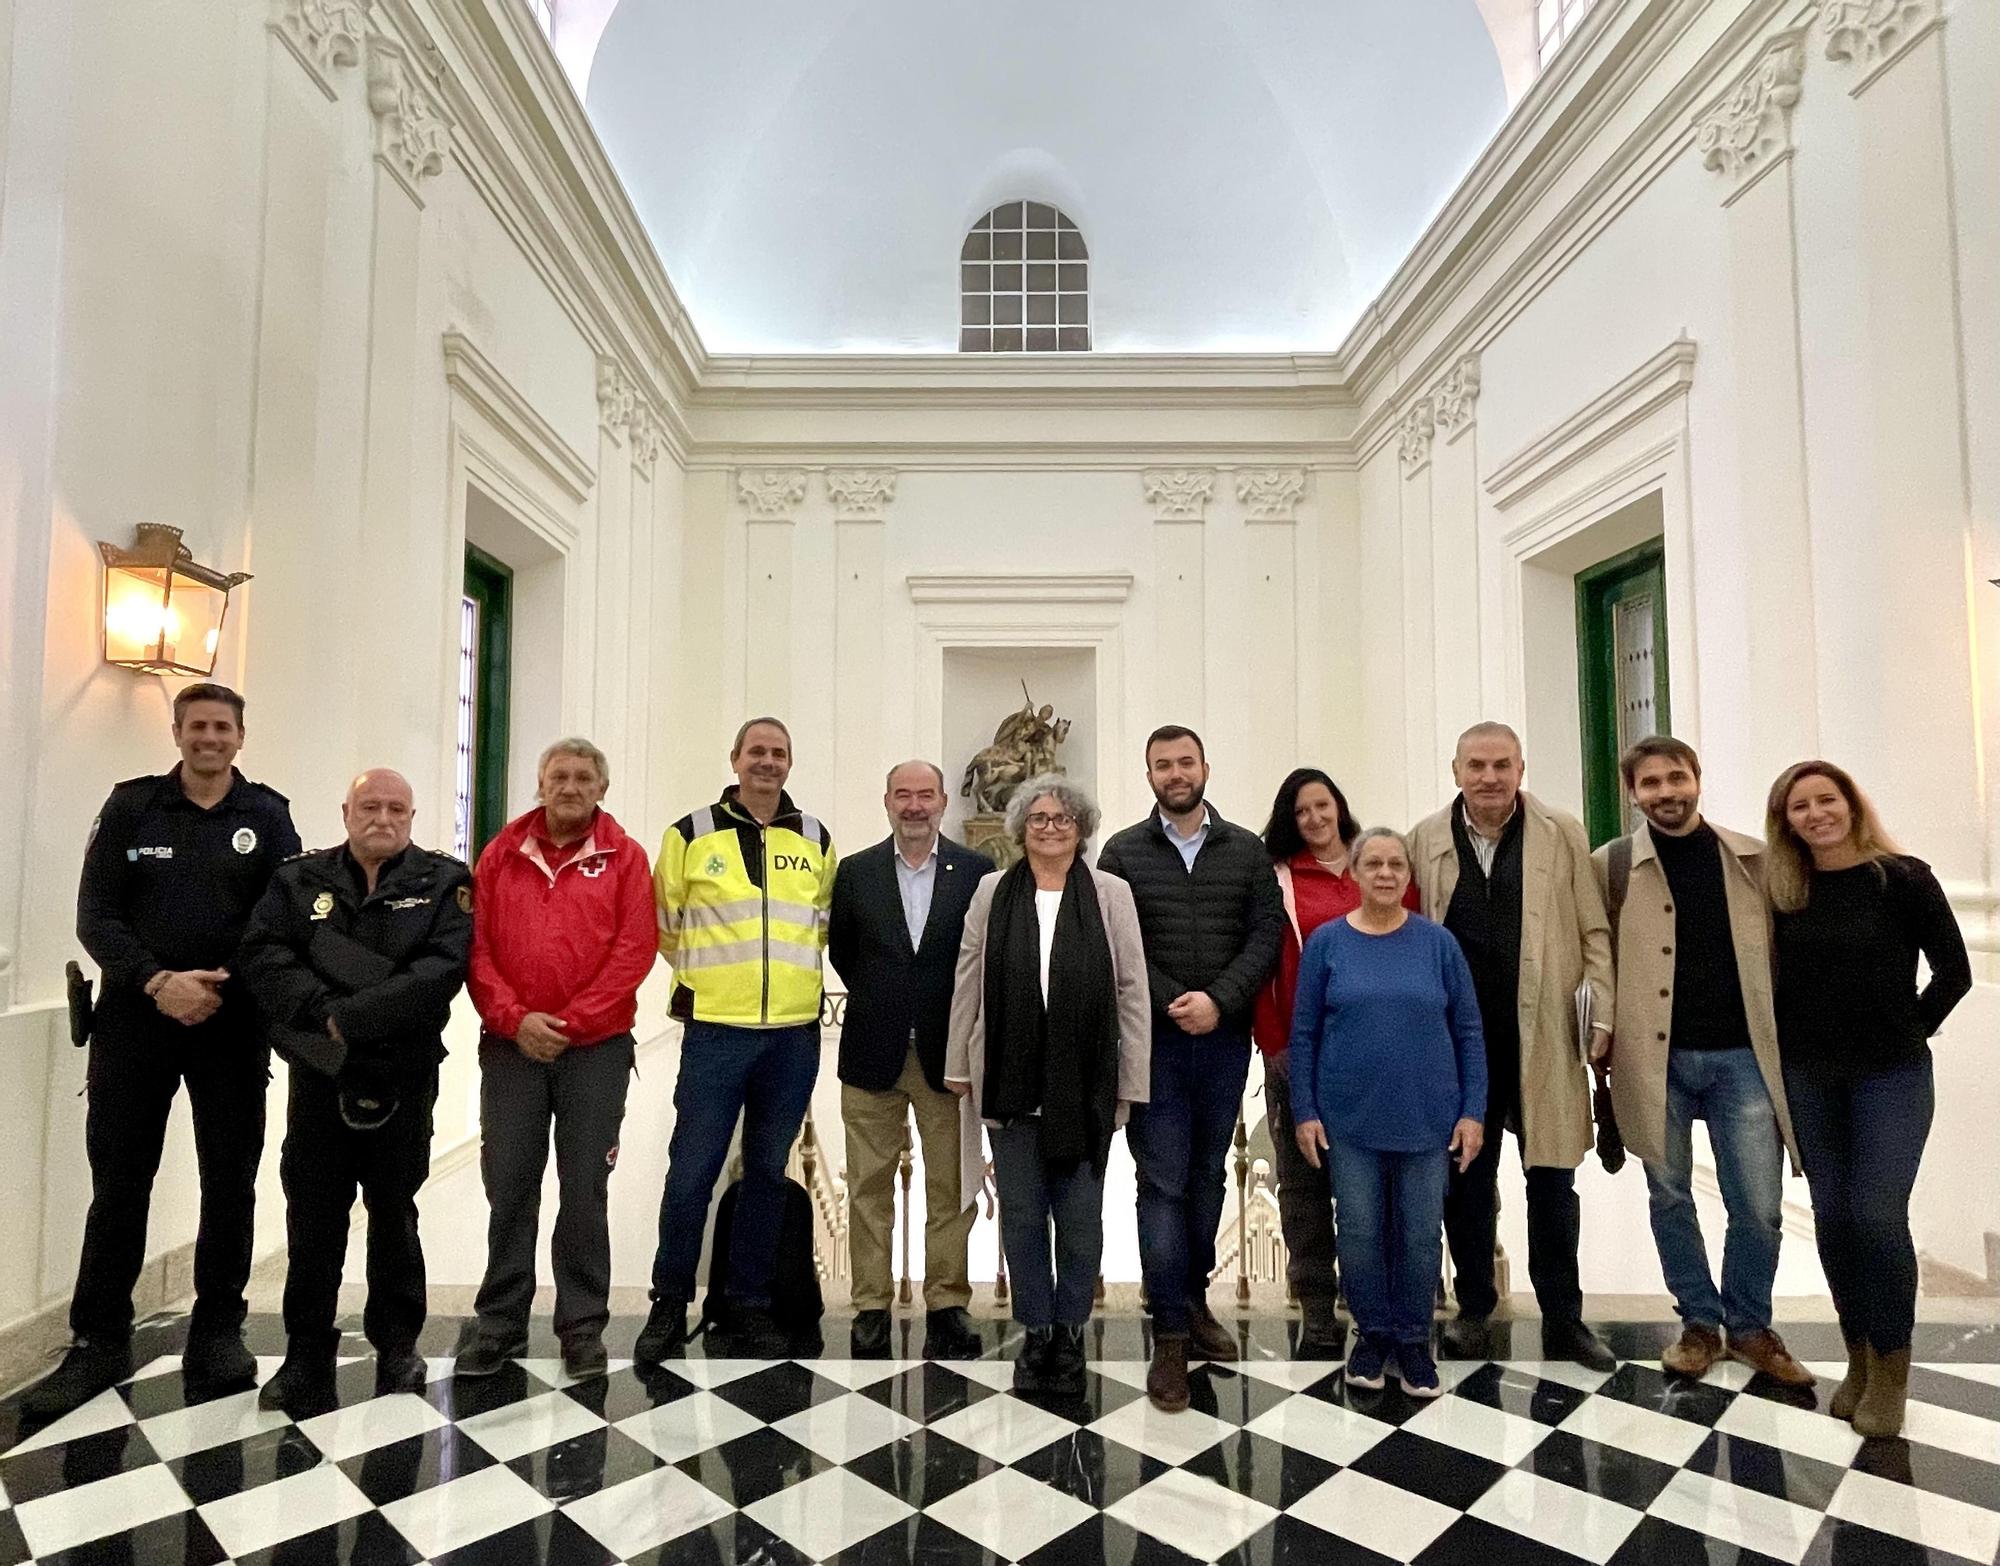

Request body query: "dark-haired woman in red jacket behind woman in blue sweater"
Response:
[1250, 766, 1416, 1360]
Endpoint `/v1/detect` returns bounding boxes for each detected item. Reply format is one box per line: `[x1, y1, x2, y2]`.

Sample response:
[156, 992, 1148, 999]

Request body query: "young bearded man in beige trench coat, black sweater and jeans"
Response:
[1592, 734, 1812, 1386]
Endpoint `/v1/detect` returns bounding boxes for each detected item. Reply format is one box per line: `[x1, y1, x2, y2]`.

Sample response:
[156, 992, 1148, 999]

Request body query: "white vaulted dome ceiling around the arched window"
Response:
[584, 0, 1506, 352]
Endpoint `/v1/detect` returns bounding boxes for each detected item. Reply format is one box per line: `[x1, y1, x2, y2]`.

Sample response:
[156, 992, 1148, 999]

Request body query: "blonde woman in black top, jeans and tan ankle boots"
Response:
[1764, 762, 1972, 1436]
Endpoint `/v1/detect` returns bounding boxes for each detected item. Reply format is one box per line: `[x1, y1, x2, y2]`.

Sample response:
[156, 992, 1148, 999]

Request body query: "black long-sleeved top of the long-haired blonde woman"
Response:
[1776, 856, 1972, 1070]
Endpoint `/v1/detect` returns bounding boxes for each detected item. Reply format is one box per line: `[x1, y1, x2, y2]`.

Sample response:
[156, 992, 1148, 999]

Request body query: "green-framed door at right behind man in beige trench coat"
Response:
[1576, 540, 1672, 844]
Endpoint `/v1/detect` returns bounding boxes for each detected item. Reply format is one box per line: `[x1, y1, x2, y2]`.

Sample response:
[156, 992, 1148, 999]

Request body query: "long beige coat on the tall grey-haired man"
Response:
[1410, 792, 1612, 1168]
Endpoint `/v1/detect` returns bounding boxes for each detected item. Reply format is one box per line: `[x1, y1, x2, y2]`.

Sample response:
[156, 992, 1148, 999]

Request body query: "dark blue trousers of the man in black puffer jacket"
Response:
[1126, 1018, 1250, 1334]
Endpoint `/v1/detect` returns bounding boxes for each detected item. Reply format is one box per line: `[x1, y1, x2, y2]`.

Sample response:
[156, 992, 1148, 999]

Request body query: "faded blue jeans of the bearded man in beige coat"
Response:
[1646, 1048, 1784, 1334]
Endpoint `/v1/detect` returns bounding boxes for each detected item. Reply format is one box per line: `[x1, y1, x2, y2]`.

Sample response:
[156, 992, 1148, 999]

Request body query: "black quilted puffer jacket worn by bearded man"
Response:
[1098, 806, 1284, 1034]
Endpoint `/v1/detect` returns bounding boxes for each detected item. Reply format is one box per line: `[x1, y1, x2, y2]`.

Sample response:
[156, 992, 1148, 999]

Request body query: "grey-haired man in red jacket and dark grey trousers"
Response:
[456, 738, 658, 1378]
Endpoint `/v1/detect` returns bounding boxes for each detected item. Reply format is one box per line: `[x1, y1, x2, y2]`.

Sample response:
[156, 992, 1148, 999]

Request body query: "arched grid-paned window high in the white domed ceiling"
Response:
[958, 202, 1090, 354]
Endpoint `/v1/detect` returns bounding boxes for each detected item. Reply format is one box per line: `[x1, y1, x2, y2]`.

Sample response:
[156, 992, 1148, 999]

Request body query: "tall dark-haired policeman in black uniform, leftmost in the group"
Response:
[26, 682, 298, 1418]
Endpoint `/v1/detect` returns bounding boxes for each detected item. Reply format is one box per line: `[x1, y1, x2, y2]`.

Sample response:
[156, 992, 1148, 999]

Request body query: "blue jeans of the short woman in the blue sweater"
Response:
[1328, 1136, 1452, 1344]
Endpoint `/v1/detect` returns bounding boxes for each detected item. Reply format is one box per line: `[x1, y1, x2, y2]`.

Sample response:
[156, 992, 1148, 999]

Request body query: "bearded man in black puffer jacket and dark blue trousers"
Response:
[1098, 724, 1284, 1412]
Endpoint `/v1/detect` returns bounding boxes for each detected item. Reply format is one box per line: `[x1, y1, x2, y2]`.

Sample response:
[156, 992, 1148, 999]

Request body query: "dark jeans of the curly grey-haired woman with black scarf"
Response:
[986, 1120, 1104, 1326]
